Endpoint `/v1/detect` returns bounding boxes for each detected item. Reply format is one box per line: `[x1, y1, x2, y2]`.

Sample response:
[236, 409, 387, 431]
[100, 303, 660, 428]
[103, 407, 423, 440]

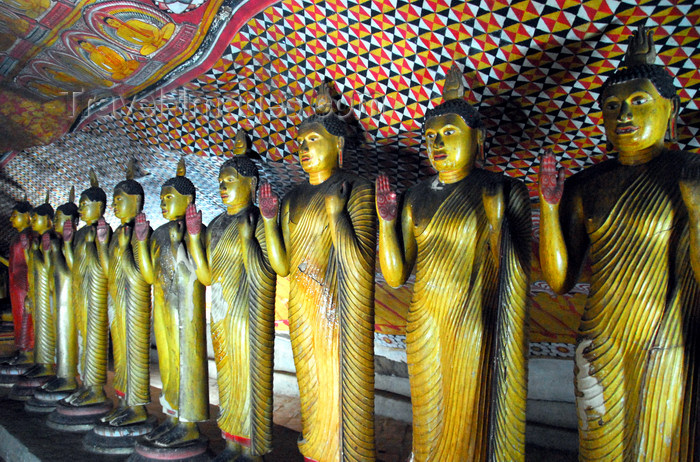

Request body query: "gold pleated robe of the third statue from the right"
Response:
[282, 170, 376, 462]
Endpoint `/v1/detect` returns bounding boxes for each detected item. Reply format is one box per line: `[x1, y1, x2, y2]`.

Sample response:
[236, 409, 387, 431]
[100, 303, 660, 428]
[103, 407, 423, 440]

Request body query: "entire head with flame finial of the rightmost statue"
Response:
[599, 27, 680, 163]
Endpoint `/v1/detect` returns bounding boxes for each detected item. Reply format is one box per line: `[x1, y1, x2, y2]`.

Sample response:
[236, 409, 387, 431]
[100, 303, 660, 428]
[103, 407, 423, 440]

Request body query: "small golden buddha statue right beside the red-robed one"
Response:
[24, 192, 56, 378]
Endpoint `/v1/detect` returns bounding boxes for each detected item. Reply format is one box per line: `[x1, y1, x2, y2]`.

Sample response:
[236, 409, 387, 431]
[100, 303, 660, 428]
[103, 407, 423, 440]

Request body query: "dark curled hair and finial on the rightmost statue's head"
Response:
[598, 26, 680, 140]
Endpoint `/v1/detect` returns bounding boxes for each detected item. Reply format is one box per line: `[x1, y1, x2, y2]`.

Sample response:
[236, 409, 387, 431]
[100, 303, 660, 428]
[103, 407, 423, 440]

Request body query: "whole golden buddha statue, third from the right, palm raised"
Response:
[260, 86, 376, 462]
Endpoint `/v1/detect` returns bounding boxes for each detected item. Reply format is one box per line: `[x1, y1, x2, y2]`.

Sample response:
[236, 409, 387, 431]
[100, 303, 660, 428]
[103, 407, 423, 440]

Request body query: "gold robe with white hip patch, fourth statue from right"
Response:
[207, 210, 276, 455]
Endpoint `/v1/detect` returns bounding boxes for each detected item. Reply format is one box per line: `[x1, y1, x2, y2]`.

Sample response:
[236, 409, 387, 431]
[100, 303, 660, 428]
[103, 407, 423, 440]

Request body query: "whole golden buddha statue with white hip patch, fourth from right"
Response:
[186, 153, 277, 462]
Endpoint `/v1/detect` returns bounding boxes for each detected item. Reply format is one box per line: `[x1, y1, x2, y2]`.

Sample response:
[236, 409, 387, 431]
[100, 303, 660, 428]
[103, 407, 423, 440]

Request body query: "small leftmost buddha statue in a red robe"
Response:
[4, 199, 34, 364]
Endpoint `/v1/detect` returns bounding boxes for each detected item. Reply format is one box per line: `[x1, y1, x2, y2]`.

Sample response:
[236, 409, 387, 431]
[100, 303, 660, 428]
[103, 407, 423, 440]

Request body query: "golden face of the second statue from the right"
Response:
[425, 114, 484, 172]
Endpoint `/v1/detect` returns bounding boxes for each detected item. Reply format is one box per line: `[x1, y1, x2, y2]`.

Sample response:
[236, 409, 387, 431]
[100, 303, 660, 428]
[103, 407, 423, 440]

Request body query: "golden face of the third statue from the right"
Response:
[297, 123, 344, 173]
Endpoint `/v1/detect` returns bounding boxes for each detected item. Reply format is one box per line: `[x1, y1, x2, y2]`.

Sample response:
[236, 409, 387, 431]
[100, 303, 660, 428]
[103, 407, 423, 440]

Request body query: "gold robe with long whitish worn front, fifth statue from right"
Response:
[150, 221, 209, 422]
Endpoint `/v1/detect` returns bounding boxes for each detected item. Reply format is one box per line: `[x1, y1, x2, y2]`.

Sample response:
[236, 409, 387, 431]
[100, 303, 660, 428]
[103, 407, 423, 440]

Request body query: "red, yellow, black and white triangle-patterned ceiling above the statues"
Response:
[87, 0, 700, 197]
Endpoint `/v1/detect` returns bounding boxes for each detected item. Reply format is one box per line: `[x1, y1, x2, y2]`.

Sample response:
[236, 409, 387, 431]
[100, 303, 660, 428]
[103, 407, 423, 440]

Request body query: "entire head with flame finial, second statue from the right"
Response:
[424, 66, 485, 183]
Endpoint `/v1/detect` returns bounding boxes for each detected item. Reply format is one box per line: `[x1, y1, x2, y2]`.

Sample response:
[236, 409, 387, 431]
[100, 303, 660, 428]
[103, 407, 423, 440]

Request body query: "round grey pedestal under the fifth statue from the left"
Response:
[83, 416, 158, 454]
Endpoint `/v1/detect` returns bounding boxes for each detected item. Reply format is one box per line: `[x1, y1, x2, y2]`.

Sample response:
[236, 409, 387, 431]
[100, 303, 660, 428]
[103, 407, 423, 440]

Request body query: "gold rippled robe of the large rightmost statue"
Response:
[561, 152, 700, 461]
